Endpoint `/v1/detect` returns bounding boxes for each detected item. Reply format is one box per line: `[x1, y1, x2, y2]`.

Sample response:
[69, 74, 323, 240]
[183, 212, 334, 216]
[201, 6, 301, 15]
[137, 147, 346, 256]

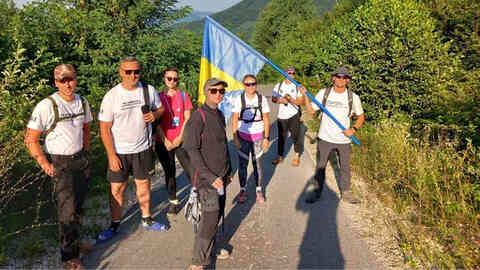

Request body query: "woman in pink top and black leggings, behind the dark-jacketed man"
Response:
[155, 68, 193, 215]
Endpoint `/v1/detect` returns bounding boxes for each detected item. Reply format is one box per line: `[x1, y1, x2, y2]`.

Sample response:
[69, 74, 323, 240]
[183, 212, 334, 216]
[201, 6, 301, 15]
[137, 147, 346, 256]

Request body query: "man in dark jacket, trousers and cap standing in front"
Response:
[183, 78, 231, 269]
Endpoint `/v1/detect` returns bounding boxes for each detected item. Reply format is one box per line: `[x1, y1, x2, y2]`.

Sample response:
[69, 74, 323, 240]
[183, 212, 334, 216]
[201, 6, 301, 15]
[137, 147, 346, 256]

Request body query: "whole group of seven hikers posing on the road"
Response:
[25, 57, 364, 269]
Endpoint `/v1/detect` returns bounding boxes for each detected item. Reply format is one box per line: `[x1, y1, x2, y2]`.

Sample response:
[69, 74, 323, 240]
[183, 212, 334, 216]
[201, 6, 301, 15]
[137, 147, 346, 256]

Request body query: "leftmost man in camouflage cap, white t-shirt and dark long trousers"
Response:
[25, 64, 92, 269]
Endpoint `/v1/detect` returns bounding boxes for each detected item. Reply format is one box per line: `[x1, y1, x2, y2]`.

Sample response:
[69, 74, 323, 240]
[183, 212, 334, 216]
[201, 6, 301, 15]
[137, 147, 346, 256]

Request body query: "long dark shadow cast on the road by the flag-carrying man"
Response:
[296, 152, 345, 269]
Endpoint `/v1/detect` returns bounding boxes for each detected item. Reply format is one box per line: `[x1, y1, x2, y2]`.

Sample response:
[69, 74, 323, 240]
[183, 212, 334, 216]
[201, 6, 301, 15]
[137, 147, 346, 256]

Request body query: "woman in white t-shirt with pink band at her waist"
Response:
[232, 74, 270, 203]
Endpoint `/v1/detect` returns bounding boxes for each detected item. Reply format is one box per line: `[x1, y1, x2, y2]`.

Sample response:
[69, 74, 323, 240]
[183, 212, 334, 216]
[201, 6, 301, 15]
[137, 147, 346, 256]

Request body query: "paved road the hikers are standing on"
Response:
[84, 86, 384, 269]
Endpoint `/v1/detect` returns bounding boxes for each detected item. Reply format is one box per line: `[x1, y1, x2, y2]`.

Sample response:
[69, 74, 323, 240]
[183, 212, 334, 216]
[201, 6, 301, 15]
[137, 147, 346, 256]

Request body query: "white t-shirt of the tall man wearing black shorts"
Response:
[98, 83, 162, 154]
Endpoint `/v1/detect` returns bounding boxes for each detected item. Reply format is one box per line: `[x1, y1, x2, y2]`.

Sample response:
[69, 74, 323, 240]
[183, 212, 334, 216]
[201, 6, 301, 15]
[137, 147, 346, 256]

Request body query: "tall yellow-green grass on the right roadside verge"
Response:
[352, 120, 480, 268]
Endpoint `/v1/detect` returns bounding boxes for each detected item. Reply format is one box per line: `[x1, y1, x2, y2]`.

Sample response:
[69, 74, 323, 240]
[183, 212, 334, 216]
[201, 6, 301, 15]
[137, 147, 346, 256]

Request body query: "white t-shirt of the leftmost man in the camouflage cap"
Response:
[27, 92, 92, 155]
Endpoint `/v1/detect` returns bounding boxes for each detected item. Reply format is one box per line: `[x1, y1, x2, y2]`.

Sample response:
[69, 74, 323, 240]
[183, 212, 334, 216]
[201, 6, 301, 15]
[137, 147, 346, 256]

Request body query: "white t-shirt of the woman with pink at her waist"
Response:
[232, 95, 270, 138]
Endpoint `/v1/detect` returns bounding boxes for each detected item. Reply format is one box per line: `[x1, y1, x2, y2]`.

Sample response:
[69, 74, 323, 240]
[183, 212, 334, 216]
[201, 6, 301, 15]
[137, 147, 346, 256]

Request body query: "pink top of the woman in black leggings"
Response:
[156, 91, 193, 142]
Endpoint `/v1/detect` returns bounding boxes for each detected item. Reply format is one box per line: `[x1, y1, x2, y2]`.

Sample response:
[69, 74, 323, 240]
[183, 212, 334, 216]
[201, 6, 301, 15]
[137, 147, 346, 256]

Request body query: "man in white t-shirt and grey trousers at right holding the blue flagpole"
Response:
[300, 67, 365, 203]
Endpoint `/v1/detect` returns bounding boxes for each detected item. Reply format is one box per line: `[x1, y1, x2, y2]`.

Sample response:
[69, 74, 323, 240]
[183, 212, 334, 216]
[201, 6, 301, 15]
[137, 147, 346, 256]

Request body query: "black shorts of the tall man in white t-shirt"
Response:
[107, 148, 153, 183]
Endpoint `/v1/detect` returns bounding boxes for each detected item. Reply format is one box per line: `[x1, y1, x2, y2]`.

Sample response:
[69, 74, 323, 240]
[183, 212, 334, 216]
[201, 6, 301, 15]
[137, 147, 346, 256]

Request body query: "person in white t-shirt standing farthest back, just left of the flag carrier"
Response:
[272, 67, 304, 167]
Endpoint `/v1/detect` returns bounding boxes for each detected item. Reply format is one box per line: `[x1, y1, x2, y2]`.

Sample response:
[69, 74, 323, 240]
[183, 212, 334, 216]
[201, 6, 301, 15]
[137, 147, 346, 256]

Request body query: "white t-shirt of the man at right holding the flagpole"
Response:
[312, 89, 363, 144]
